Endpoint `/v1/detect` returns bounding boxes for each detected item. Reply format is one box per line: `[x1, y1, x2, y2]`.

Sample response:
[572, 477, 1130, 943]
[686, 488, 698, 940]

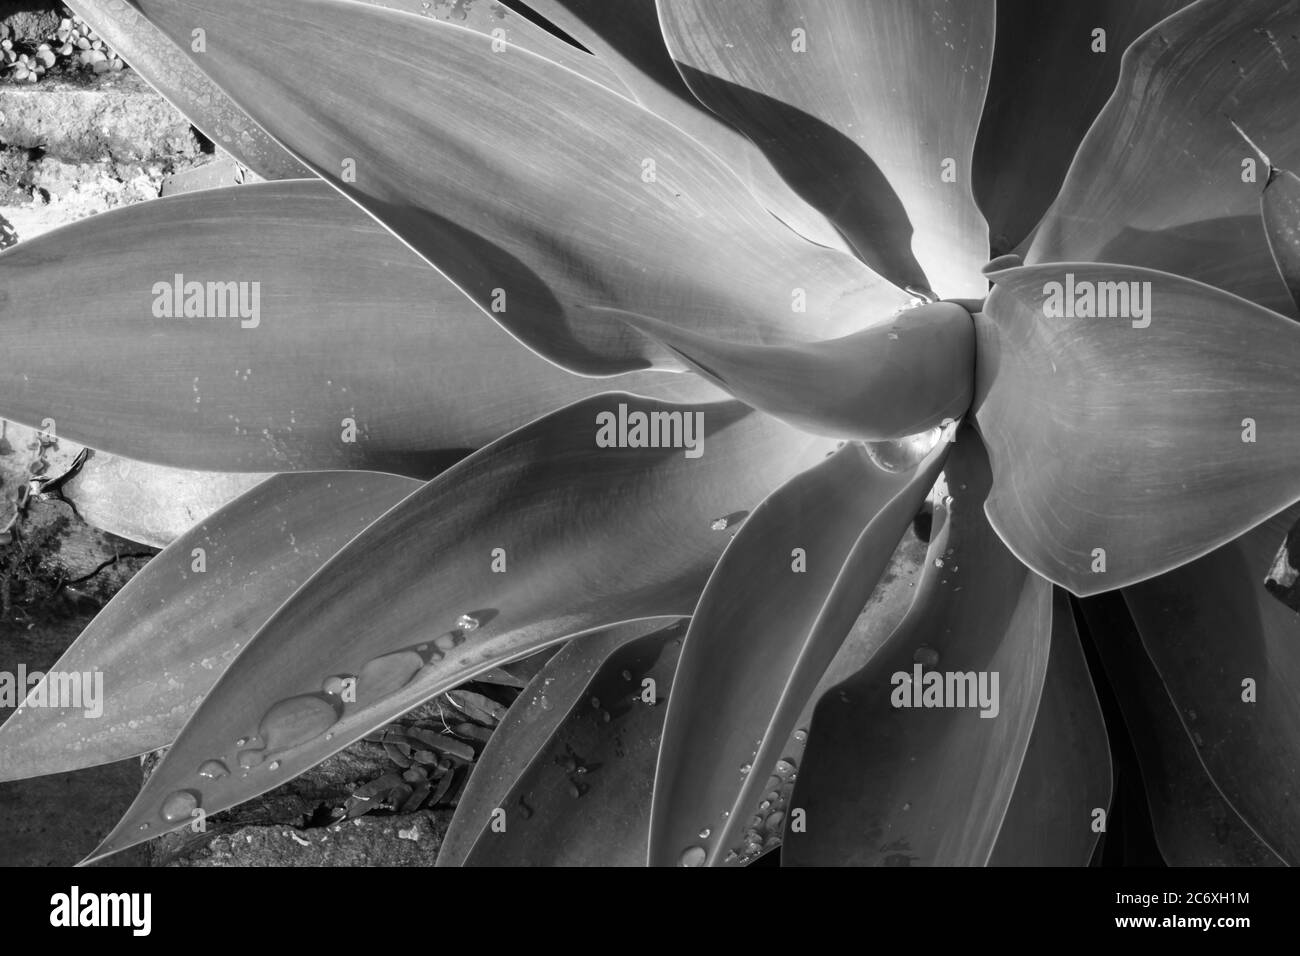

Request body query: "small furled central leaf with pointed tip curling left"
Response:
[595, 302, 975, 440]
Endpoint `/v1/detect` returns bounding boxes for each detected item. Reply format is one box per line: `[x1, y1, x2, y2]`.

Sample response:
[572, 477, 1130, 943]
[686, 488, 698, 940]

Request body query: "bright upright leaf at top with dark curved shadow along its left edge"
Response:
[659, 0, 995, 298]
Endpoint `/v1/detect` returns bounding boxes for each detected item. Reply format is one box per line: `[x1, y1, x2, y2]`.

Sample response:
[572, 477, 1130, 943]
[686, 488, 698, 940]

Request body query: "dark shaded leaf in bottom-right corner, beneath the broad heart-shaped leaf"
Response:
[1123, 507, 1300, 865]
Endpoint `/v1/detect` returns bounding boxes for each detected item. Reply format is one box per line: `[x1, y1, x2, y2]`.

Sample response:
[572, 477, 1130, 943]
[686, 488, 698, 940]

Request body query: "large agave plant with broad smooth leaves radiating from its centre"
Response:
[0, 0, 1300, 865]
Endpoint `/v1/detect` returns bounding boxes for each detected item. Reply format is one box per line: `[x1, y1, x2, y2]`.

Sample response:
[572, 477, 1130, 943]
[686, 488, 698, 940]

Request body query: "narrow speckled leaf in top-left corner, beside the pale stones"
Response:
[68, 0, 312, 179]
